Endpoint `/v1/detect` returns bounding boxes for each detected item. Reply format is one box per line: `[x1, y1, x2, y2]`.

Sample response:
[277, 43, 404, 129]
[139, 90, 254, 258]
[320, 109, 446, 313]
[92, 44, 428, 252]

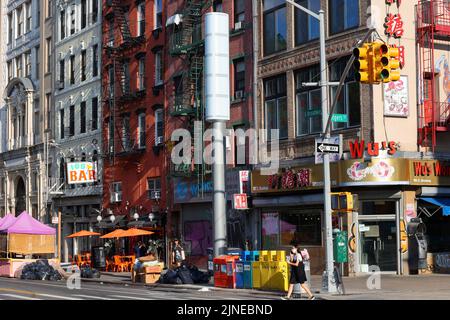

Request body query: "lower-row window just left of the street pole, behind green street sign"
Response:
[295, 65, 322, 136]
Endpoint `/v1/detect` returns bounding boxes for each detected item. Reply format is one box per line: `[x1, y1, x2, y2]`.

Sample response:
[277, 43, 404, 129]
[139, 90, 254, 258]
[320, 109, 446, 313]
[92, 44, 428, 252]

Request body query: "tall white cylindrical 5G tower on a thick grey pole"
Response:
[205, 12, 230, 257]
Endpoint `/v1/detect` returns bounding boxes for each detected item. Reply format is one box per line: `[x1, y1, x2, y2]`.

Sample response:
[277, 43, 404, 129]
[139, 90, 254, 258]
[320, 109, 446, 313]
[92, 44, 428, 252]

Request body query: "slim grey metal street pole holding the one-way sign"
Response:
[286, 0, 337, 293]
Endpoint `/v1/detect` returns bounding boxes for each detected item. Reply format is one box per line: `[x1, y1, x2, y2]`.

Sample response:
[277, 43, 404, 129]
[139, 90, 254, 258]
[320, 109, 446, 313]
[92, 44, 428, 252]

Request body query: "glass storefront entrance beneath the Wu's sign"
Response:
[358, 201, 398, 273]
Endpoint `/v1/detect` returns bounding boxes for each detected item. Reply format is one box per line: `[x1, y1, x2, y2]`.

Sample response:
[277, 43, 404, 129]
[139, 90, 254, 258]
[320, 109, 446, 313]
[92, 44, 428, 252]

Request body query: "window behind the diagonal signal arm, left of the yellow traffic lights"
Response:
[330, 58, 361, 130]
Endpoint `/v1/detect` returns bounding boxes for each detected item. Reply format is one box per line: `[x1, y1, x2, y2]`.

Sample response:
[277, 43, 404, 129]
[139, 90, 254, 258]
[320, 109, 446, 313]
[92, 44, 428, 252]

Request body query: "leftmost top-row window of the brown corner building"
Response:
[263, 0, 287, 56]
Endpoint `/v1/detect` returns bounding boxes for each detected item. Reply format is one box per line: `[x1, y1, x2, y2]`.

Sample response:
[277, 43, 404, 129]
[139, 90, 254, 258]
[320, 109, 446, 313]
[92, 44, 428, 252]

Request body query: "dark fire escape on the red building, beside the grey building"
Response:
[103, 0, 145, 160]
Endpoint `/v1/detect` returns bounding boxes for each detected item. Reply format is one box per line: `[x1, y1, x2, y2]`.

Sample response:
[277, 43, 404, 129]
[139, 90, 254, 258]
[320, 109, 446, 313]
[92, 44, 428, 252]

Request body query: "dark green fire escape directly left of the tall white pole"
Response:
[169, 0, 212, 180]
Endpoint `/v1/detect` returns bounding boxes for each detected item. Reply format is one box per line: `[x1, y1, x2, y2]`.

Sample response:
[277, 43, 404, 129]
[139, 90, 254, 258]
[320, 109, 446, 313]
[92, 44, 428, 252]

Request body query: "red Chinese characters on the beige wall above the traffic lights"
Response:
[384, 0, 405, 69]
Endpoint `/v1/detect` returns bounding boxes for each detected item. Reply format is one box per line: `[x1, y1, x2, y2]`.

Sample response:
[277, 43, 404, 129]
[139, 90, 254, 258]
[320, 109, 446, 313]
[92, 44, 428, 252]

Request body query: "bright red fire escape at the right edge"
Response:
[416, 0, 450, 151]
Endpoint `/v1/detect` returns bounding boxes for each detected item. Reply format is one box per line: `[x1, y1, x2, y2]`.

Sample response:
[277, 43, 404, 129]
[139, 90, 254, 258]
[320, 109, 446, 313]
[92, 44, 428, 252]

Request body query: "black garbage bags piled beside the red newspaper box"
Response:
[158, 265, 210, 284]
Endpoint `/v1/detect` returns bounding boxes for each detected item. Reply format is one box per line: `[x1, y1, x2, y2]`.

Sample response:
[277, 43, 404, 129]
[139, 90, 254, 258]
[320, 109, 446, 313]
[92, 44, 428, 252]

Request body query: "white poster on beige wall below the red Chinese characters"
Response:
[383, 76, 409, 118]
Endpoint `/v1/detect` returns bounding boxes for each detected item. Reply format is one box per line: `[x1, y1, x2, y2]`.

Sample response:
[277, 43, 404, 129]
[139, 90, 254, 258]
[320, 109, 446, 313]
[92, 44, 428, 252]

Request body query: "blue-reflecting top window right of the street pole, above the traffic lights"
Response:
[329, 0, 359, 34]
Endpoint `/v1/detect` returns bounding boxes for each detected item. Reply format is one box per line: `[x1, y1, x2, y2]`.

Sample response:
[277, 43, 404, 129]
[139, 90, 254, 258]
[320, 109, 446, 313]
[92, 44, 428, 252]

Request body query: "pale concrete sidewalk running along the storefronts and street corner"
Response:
[78, 272, 450, 300]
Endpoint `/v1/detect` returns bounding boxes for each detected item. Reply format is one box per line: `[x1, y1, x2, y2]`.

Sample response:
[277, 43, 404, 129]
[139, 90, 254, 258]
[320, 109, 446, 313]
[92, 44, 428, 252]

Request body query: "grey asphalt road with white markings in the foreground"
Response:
[0, 278, 279, 300]
